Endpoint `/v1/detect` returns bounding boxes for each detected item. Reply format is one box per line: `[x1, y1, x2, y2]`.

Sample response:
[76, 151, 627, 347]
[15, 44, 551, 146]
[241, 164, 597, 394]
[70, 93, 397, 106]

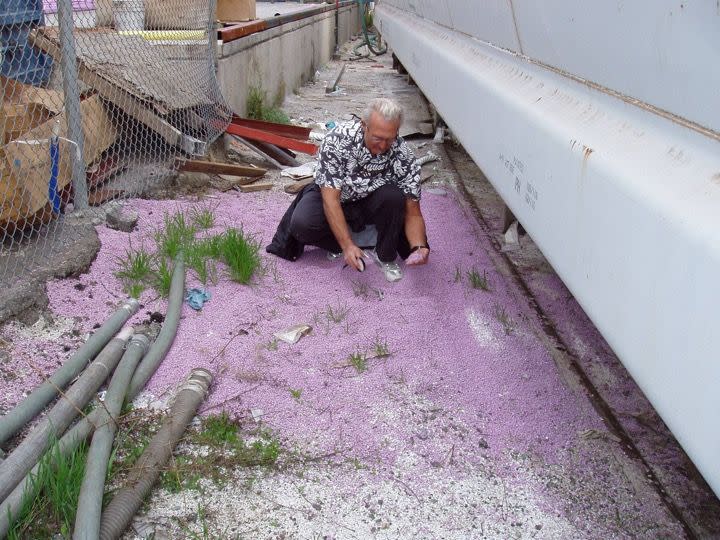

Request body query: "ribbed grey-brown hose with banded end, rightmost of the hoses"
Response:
[100, 369, 212, 540]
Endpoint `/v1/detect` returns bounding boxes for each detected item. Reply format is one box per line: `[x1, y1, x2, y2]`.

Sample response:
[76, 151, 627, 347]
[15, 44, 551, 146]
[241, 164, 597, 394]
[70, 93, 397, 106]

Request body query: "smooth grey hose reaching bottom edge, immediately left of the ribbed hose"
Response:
[73, 334, 150, 540]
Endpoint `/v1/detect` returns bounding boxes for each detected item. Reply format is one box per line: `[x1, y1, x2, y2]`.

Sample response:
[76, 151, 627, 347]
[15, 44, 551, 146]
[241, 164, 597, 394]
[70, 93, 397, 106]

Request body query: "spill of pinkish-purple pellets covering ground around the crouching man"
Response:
[3, 192, 620, 520]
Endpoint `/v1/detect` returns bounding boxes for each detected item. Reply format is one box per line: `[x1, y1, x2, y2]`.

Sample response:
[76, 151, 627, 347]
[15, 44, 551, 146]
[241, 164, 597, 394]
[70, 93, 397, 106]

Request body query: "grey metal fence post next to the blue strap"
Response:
[57, 0, 88, 210]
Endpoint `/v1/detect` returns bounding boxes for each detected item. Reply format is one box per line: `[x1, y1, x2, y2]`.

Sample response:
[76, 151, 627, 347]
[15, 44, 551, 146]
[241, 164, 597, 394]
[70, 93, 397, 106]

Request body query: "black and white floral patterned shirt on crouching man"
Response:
[315, 120, 420, 202]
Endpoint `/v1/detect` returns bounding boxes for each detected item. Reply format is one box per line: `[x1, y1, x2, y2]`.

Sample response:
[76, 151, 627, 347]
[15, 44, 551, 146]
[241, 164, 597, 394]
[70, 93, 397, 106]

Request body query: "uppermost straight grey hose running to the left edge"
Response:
[0, 328, 133, 501]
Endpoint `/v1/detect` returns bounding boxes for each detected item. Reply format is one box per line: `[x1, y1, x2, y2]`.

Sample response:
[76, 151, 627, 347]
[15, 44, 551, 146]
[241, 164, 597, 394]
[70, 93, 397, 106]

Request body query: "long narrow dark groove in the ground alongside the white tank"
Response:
[446, 148, 698, 540]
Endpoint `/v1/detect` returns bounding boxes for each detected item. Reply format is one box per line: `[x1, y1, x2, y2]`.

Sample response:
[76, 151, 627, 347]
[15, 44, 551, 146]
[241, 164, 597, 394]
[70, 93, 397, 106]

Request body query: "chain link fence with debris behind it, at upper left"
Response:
[0, 0, 231, 286]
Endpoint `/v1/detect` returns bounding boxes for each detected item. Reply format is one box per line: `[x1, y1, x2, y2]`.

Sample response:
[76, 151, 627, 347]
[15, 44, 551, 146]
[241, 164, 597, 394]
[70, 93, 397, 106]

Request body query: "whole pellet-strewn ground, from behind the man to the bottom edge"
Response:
[0, 37, 720, 539]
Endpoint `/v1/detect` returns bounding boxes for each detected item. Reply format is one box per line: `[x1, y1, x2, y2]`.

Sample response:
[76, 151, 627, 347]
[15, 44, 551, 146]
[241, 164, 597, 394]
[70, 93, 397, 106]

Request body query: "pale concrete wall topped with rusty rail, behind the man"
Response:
[218, 4, 362, 115]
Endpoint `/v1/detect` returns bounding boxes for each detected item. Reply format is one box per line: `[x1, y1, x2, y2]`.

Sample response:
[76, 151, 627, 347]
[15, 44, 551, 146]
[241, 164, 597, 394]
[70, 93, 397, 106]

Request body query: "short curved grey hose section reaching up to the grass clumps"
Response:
[128, 257, 185, 396]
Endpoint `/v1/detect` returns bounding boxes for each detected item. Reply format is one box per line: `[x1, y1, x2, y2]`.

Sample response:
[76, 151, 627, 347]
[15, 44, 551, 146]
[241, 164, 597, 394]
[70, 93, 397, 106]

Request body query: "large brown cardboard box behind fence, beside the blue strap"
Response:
[0, 96, 117, 227]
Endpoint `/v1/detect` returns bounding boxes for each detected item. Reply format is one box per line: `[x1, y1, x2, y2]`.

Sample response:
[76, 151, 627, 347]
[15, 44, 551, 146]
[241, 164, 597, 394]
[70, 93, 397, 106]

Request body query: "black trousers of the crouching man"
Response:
[290, 184, 410, 262]
